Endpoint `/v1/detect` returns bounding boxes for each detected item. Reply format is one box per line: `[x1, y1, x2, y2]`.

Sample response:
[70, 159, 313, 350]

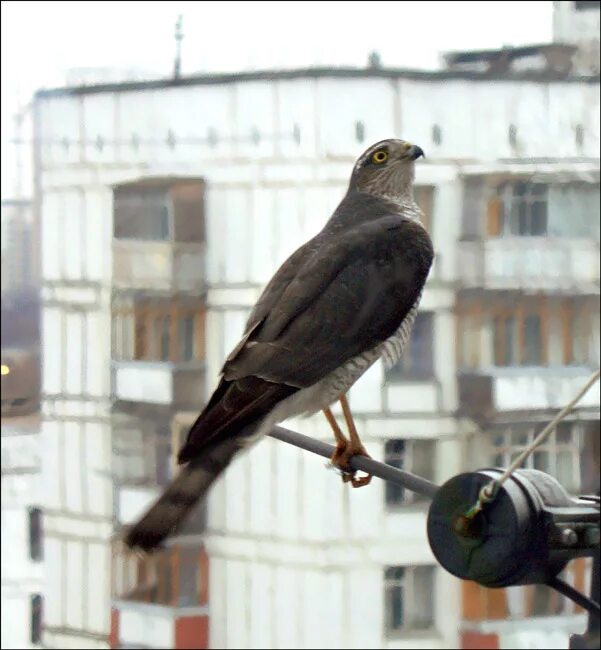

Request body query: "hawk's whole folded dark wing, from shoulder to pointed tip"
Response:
[178, 216, 433, 463]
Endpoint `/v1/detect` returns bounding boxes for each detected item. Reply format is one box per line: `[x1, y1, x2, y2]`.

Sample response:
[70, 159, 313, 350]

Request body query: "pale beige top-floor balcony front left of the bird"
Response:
[113, 239, 205, 293]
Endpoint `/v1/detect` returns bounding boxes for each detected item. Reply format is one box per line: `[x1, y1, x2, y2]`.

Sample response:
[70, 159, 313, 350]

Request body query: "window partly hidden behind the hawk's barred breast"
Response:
[386, 312, 434, 382]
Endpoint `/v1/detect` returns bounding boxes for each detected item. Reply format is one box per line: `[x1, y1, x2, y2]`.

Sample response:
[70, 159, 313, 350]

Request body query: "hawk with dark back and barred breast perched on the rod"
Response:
[125, 139, 434, 551]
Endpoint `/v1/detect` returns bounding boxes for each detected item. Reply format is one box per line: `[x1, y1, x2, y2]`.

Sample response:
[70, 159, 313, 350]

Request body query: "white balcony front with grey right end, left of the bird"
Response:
[113, 361, 205, 408]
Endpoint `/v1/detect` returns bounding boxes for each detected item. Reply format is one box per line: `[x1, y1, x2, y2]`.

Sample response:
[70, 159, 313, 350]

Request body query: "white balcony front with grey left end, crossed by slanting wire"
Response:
[459, 367, 600, 420]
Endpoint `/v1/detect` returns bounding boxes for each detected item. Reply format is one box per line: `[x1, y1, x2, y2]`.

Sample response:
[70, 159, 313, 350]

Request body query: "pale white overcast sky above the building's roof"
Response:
[1, 0, 552, 196]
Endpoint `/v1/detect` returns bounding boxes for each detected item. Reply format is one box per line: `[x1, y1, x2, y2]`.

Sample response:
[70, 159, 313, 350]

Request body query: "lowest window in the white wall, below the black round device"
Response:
[384, 566, 434, 636]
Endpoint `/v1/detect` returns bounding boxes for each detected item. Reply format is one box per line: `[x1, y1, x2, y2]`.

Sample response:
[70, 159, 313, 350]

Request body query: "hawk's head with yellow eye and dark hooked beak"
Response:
[349, 139, 424, 200]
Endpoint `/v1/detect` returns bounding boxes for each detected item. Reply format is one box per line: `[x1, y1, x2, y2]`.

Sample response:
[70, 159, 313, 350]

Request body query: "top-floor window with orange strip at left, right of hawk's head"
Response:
[488, 182, 548, 237]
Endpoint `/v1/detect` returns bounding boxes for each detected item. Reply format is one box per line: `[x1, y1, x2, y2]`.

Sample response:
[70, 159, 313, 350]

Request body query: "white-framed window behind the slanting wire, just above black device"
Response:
[492, 421, 588, 493]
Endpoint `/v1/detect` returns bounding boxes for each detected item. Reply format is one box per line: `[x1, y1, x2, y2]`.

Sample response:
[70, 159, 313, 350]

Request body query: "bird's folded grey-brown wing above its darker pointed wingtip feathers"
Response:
[224, 216, 433, 388]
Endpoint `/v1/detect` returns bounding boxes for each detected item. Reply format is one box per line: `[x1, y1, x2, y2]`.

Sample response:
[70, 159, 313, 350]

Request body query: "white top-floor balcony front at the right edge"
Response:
[458, 237, 599, 295]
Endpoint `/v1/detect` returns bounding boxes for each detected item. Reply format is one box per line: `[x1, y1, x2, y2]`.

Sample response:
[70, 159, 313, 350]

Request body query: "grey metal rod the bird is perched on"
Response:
[269, 427, 438, 499]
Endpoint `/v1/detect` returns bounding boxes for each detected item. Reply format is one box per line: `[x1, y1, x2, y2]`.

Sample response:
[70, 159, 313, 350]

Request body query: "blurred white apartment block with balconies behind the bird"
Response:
[2, 2, 600, 649]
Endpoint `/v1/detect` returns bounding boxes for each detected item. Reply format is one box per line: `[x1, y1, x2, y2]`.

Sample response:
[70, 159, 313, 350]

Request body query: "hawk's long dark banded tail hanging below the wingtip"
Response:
[124, 437, 241, 551]
